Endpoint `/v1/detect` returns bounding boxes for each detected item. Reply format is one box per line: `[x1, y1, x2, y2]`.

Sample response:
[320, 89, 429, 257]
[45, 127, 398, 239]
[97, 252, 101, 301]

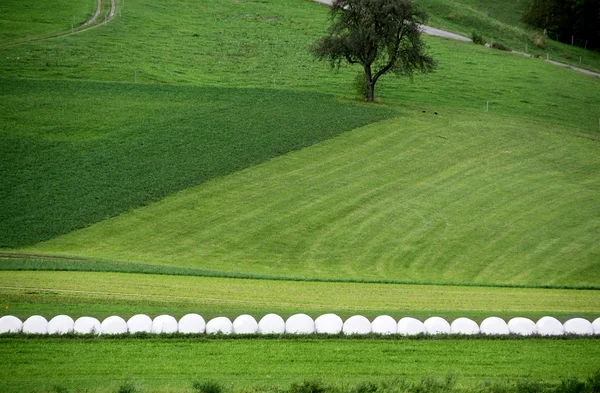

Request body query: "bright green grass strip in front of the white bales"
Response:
[0, 339, 600, 393]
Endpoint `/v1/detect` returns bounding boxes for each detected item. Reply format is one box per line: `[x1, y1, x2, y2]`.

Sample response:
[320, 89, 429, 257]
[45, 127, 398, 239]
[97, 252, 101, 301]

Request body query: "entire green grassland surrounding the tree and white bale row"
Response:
[0, 0, 600, 393]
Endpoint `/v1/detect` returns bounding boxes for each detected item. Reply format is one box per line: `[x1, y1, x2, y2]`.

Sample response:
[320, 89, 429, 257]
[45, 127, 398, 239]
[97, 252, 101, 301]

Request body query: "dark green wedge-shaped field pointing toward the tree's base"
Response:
[0, 79, 393, 248]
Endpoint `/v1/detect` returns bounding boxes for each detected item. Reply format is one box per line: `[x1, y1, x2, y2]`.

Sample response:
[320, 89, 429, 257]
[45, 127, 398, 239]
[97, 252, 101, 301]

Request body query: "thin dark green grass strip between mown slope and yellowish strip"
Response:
[0, 253, 600, 291]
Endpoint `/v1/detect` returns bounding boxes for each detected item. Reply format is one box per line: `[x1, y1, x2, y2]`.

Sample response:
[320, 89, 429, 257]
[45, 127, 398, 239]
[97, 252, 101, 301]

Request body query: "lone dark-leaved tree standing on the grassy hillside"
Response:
[312, 0, 435, 102]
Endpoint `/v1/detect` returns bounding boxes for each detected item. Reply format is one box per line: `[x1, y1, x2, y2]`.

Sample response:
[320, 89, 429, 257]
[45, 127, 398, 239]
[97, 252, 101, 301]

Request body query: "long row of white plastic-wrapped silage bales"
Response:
[0, 314, 600, 336]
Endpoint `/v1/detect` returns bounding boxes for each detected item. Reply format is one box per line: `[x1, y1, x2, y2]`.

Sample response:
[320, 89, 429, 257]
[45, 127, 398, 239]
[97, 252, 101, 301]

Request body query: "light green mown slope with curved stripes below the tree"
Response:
[26, 109, 600, 285]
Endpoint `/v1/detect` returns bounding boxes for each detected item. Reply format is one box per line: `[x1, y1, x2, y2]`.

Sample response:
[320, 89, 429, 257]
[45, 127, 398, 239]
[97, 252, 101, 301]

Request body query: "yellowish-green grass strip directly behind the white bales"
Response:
[0, 271, 600, 322]
